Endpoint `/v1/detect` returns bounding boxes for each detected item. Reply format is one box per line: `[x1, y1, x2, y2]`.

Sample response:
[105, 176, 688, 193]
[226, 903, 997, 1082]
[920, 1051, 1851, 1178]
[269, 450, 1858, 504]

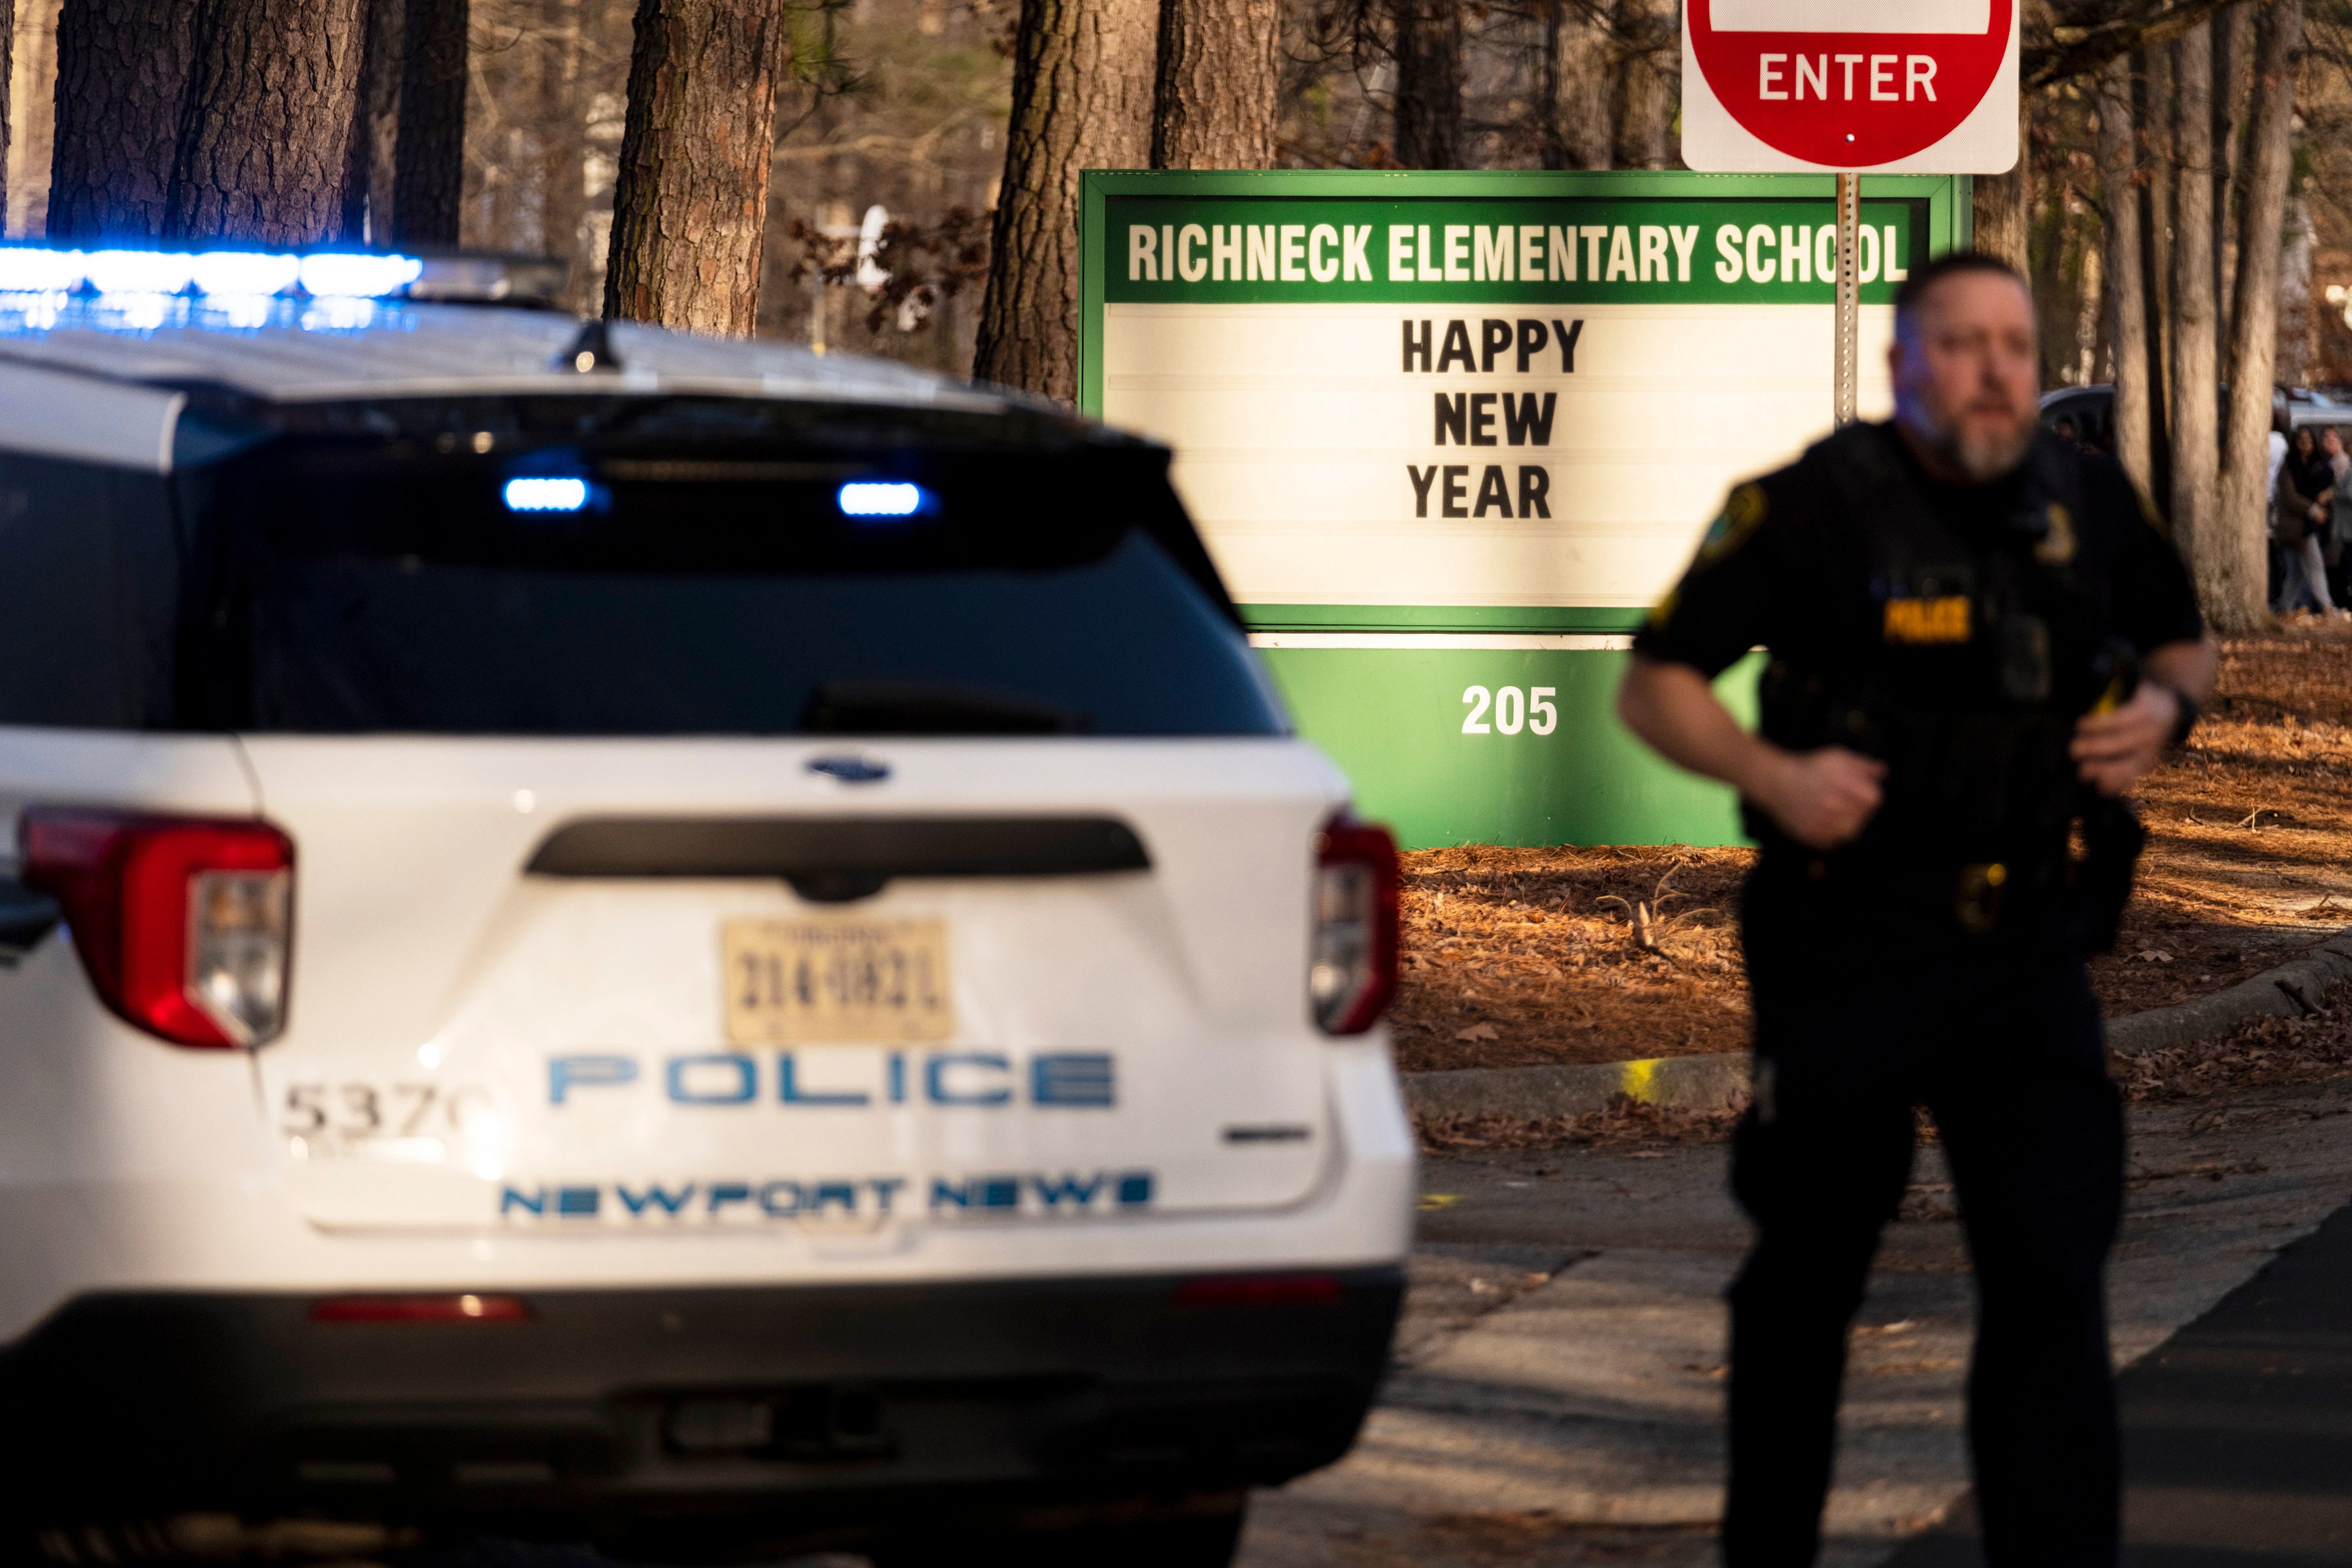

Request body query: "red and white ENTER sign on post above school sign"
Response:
[1682, 0, 2018, 174]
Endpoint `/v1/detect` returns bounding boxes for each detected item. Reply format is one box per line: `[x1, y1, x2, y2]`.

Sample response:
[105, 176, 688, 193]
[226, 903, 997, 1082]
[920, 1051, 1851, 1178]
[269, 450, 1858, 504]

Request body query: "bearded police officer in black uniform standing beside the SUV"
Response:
[1618, 254, 2215, 1568]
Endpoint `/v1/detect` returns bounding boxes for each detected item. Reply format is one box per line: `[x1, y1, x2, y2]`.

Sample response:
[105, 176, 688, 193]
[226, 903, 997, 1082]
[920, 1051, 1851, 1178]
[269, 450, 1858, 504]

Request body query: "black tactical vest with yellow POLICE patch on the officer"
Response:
[1748, 425, 2138, 947]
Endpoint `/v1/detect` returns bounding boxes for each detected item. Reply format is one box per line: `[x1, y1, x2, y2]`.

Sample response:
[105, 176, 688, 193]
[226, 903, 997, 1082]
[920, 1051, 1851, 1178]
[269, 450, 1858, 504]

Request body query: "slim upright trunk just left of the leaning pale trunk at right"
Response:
[2171, 26, 2211, 606]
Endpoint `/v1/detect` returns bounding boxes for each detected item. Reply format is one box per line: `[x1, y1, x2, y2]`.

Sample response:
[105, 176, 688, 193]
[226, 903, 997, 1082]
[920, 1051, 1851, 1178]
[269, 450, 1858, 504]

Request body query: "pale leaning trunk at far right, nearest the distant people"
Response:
[2197, 0, 2302, 632]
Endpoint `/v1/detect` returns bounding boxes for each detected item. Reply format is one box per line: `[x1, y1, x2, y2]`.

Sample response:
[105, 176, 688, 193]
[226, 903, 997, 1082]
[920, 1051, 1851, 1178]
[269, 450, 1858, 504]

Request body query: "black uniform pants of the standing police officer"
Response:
[1724, 926, 2124, 1568]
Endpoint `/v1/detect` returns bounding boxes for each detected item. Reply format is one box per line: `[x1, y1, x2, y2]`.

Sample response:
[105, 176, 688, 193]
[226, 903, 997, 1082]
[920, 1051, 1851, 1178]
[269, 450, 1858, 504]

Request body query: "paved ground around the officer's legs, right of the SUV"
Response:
[1242, 1081, 2352, 1568]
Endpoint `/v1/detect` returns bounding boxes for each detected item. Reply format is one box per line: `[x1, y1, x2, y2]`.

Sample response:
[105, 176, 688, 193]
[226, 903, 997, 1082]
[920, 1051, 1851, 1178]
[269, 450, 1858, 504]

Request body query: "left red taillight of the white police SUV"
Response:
[19, 806, 294, 1046]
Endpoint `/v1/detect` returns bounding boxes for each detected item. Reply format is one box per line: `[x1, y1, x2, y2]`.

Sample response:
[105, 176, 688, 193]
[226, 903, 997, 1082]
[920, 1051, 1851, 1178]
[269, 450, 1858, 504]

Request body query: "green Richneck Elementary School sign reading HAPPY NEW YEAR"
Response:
[1079, 172, 1968, 846]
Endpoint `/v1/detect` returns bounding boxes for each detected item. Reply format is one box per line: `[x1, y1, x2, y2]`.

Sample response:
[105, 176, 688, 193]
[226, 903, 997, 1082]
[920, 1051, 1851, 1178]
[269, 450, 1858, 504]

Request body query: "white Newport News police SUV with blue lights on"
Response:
[0, 249, 1411, 1563]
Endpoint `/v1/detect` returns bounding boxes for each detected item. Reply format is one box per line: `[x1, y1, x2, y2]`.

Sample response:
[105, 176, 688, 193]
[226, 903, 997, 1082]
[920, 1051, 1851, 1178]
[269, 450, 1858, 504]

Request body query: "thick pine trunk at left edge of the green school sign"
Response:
[972, 0, 1160, 402]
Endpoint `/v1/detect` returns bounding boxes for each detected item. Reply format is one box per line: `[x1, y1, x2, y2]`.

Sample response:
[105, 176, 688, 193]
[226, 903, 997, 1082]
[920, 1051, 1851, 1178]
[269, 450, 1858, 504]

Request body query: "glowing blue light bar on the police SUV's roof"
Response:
[0, 244, 564, 303]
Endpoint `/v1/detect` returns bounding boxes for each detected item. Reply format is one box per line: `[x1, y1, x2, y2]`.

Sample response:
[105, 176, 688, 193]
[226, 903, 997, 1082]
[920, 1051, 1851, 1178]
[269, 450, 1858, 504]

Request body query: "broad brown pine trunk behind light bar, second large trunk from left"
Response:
[162, 0, 367, 244]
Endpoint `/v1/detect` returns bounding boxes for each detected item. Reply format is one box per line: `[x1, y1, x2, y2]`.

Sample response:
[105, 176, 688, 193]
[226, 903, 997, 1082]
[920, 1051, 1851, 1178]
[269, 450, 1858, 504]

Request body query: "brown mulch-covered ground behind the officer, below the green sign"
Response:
[1390, 621, 2352, 1072]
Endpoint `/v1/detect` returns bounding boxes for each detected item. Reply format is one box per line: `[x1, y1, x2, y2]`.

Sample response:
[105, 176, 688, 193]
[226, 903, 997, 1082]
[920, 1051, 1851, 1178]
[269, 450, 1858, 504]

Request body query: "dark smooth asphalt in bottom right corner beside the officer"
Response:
[1889, 1206, 2352, 1568]
